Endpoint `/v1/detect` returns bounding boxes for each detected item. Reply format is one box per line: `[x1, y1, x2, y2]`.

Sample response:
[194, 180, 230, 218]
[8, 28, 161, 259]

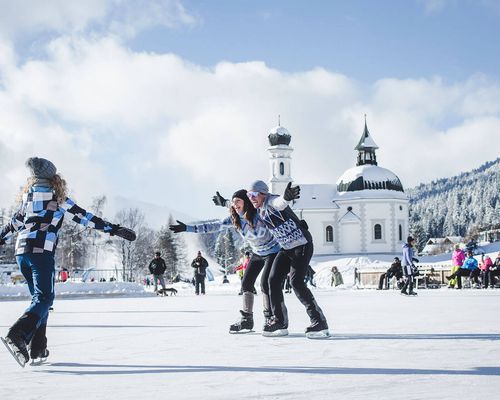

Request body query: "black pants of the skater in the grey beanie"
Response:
[269, 243, 326, 324]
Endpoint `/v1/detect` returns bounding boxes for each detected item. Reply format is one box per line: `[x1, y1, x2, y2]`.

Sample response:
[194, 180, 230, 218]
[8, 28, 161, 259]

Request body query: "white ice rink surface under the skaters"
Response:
[0, 285, 500, 400]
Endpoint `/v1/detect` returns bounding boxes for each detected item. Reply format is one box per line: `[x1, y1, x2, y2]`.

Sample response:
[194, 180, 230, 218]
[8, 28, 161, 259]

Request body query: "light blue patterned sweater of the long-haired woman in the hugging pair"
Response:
[186, 215, 281, 256]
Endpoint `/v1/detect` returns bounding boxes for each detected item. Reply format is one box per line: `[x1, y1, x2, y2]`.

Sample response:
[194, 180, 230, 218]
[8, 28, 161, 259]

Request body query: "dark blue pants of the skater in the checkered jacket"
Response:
[11, 253, 55, 349]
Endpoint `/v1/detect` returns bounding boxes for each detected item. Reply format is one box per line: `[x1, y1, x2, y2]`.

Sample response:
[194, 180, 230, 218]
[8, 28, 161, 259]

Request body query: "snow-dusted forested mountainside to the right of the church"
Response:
[407, 158, 500, 237]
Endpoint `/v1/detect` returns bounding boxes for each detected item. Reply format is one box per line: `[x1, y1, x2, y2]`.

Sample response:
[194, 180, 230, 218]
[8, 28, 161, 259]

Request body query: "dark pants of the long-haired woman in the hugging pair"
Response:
[241, 253, 277, 317]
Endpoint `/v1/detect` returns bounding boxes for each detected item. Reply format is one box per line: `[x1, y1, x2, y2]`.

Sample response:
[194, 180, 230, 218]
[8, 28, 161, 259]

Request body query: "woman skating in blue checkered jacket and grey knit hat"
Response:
[0, 157, 135, 366]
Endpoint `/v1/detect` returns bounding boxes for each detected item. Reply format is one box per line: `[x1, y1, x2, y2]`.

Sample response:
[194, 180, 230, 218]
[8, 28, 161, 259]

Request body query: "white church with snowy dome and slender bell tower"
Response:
[268, 117, 408, 255]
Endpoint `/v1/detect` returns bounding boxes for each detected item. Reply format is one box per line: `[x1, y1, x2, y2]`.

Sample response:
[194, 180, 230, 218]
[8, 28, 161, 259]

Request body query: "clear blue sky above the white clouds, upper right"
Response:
[131, 0, 500, 82]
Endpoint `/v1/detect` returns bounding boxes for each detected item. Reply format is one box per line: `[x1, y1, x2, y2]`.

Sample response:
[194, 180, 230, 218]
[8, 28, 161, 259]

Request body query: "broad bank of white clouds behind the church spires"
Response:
[0, 32, 500, 215]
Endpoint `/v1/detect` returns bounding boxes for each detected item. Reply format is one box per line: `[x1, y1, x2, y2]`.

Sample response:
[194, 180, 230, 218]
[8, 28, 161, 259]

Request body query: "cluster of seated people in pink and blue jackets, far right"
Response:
[446, 245, 500, 289]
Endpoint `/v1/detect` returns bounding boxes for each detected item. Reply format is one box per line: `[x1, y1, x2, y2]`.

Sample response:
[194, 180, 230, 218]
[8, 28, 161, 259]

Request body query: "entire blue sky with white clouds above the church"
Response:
[0, 0, 500, 222]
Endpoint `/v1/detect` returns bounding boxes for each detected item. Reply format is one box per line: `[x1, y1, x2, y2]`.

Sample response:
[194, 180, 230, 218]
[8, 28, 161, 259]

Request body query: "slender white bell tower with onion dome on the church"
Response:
[267, 121, 293, 195]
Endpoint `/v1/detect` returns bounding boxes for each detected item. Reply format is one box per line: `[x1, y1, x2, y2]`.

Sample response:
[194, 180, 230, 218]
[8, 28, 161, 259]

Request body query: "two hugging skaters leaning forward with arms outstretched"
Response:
[170, 180, 329, 338]
